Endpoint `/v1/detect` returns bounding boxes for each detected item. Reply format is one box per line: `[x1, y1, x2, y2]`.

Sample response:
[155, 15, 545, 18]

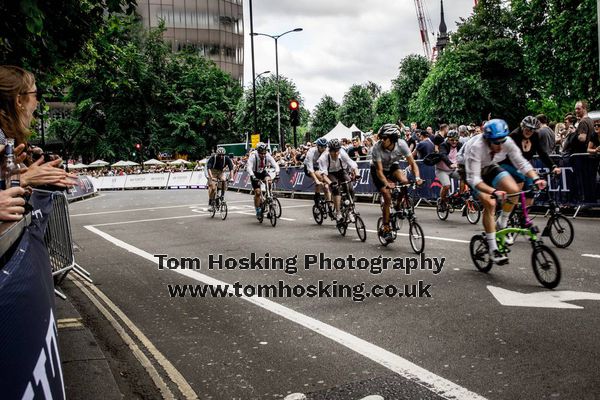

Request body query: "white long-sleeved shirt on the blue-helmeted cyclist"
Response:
[464, 135, 533, 187]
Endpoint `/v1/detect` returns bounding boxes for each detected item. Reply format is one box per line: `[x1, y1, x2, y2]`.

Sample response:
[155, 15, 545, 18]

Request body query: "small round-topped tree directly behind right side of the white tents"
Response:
[338, 84, 373, 129]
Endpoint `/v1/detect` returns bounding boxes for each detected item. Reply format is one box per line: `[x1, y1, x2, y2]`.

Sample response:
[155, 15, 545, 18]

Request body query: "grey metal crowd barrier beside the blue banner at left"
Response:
[44, 192, 93, 299]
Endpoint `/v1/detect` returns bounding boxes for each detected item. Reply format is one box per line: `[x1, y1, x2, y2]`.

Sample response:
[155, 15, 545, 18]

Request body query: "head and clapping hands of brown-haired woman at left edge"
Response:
[0, 65, 76, 187]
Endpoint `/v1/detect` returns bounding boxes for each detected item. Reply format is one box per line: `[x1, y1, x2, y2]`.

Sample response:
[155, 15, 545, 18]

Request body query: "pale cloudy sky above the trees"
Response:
[244, 0, 474, 111]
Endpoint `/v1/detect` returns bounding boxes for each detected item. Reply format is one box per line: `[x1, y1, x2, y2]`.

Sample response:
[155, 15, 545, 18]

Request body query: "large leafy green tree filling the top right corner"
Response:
[511, 0, 600, 120]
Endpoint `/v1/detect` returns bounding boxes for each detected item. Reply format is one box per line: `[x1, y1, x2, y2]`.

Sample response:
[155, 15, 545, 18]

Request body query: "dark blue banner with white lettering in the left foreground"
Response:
[0, 191, 65, 400]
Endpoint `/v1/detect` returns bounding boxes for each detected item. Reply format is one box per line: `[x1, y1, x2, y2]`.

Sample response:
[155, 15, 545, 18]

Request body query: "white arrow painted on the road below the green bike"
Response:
[487, 286, 600, 310]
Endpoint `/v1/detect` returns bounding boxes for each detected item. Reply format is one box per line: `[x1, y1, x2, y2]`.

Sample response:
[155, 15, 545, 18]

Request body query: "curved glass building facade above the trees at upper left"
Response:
[137, 0, 244, 84]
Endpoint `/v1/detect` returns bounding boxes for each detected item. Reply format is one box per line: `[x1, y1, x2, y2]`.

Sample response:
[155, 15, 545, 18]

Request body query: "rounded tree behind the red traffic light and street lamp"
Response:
[235, 75, 300, 143]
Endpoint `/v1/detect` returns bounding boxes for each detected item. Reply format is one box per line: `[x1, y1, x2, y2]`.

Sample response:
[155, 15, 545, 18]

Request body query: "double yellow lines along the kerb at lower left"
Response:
[71, 278, 198, 399]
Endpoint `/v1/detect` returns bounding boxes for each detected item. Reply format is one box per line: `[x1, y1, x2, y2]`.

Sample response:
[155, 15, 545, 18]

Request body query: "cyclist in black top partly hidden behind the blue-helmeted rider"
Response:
[497, 115, 560, 225]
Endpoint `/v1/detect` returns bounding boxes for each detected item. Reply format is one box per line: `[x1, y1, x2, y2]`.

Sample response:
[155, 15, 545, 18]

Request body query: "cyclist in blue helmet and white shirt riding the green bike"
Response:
[464, 119, 546, 264]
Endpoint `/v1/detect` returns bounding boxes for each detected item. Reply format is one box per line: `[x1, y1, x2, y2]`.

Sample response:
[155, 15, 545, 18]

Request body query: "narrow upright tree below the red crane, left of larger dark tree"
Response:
[392, 54, 431, 121]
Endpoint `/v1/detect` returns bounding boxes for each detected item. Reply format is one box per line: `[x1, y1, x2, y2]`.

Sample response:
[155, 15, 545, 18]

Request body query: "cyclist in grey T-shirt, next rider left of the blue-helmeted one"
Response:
[371, 124, 423, 241]
